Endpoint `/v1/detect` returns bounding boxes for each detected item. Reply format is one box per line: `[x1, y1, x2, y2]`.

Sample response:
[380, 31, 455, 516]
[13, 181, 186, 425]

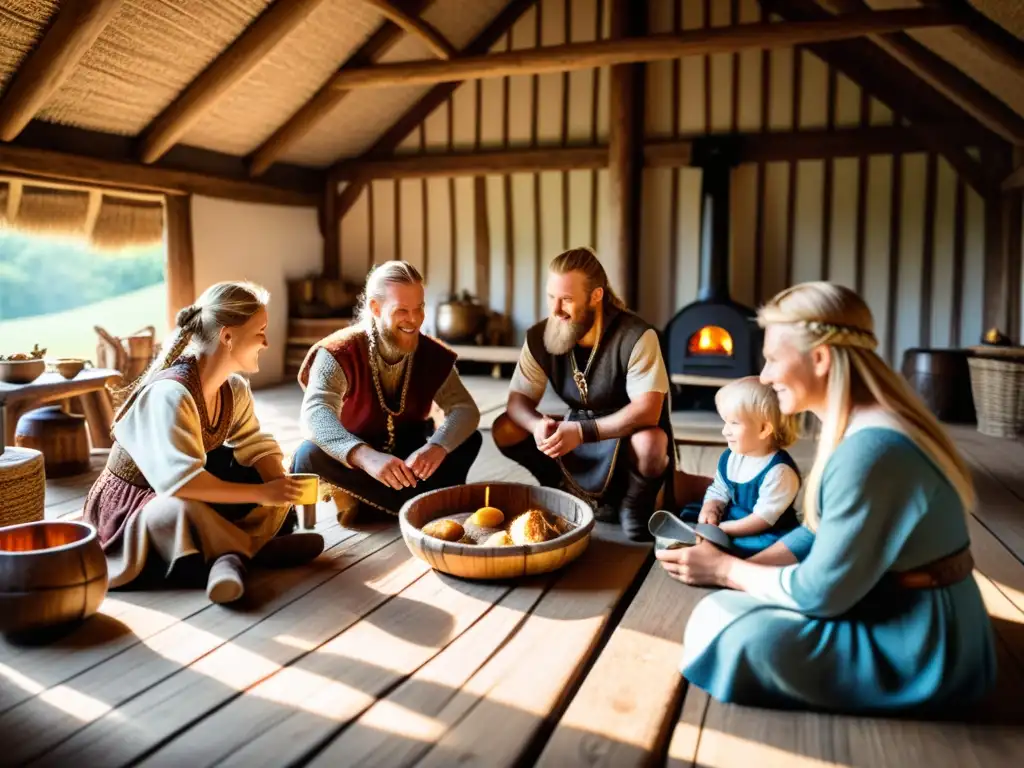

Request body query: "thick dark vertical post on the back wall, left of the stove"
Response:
[607, 0, 647, 308]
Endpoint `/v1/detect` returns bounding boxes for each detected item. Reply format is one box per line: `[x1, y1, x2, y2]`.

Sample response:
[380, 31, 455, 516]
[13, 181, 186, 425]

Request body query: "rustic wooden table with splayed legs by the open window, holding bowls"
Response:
[0, 368, 121, 451]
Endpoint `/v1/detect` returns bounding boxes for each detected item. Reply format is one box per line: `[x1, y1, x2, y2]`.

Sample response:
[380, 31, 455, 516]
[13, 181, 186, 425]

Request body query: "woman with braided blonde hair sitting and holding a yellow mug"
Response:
[85, 283, 324, 603]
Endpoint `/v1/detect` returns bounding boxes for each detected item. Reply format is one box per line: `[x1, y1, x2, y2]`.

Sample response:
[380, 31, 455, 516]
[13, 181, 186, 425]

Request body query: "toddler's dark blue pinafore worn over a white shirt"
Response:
[680, 449, 810, 560]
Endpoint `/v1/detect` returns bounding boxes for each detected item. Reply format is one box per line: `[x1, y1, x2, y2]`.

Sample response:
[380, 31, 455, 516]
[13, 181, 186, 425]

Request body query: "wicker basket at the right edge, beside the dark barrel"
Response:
[968, 347, 1024, 437]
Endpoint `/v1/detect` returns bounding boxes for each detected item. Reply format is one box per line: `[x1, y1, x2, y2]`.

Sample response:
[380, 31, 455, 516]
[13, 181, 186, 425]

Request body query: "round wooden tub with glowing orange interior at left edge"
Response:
[0, 520, 106, 634]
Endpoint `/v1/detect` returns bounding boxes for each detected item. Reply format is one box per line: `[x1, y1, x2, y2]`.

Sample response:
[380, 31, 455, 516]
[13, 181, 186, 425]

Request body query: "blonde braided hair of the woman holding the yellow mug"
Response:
[114, 282, 270, 422]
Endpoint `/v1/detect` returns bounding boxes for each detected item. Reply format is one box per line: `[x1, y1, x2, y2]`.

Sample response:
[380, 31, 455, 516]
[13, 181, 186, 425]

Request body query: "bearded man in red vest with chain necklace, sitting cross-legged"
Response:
[292, 261, 482, 514]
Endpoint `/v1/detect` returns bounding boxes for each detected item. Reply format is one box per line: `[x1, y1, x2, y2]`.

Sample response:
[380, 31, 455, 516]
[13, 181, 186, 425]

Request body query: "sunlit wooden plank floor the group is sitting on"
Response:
[8, 379, 1024, 768]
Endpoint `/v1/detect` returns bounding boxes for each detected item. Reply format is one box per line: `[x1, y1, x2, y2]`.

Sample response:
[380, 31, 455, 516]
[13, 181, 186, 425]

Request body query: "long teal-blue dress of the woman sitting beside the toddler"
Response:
[681, 426, 995, 714]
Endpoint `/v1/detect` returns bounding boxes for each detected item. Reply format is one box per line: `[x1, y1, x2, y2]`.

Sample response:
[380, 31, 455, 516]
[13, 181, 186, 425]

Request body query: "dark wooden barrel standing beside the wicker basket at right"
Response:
[902, 348, 977, 424]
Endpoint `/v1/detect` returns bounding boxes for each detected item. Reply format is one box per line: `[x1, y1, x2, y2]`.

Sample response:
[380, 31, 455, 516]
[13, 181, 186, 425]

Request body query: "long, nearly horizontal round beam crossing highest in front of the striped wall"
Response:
[325, 8, 949, 89]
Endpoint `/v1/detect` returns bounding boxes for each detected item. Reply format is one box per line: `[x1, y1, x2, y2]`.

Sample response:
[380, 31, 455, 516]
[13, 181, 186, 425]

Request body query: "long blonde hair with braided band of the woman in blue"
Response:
[758, 282, 975, 530]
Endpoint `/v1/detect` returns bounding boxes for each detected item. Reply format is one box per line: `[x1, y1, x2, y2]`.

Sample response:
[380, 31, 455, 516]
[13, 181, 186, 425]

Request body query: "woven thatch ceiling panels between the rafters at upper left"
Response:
[0, 0, 507, 167]
